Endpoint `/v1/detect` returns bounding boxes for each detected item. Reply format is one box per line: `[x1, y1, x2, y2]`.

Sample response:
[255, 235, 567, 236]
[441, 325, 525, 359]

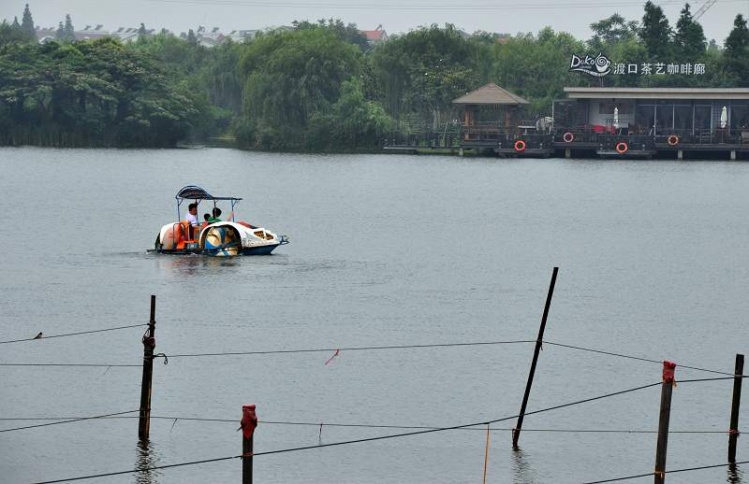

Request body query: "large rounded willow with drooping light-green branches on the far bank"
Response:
[237, 27, 362, 150]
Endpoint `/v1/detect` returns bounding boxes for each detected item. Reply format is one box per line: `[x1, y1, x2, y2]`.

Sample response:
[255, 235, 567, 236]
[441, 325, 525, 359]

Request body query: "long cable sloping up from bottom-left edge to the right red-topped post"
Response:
[29, 382, 662, 484]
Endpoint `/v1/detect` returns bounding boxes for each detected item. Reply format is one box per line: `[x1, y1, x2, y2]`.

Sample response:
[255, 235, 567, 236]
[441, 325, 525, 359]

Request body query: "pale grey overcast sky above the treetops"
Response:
[0, 0, 749, 44]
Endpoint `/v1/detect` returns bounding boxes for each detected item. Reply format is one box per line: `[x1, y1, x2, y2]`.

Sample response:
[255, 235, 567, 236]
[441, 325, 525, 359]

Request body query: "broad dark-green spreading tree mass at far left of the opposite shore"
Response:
[0, 39, 199, 146]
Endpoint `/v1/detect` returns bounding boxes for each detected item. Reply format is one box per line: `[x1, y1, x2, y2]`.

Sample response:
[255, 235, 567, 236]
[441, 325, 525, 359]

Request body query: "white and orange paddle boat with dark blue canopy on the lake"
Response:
[149, 185, 289, 257]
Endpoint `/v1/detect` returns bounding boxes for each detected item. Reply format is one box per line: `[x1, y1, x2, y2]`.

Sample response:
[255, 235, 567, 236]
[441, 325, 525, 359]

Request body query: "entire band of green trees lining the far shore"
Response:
[0, 1, 749, 152]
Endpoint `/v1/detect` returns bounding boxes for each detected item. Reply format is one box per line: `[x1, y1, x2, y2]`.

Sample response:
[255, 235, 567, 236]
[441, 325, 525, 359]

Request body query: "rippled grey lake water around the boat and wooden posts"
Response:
[0, 148, 749, 484]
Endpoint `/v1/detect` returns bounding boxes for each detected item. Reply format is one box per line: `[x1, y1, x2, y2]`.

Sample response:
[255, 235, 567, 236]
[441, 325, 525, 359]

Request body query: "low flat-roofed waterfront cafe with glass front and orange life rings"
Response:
[553, 87, 749, 160]
